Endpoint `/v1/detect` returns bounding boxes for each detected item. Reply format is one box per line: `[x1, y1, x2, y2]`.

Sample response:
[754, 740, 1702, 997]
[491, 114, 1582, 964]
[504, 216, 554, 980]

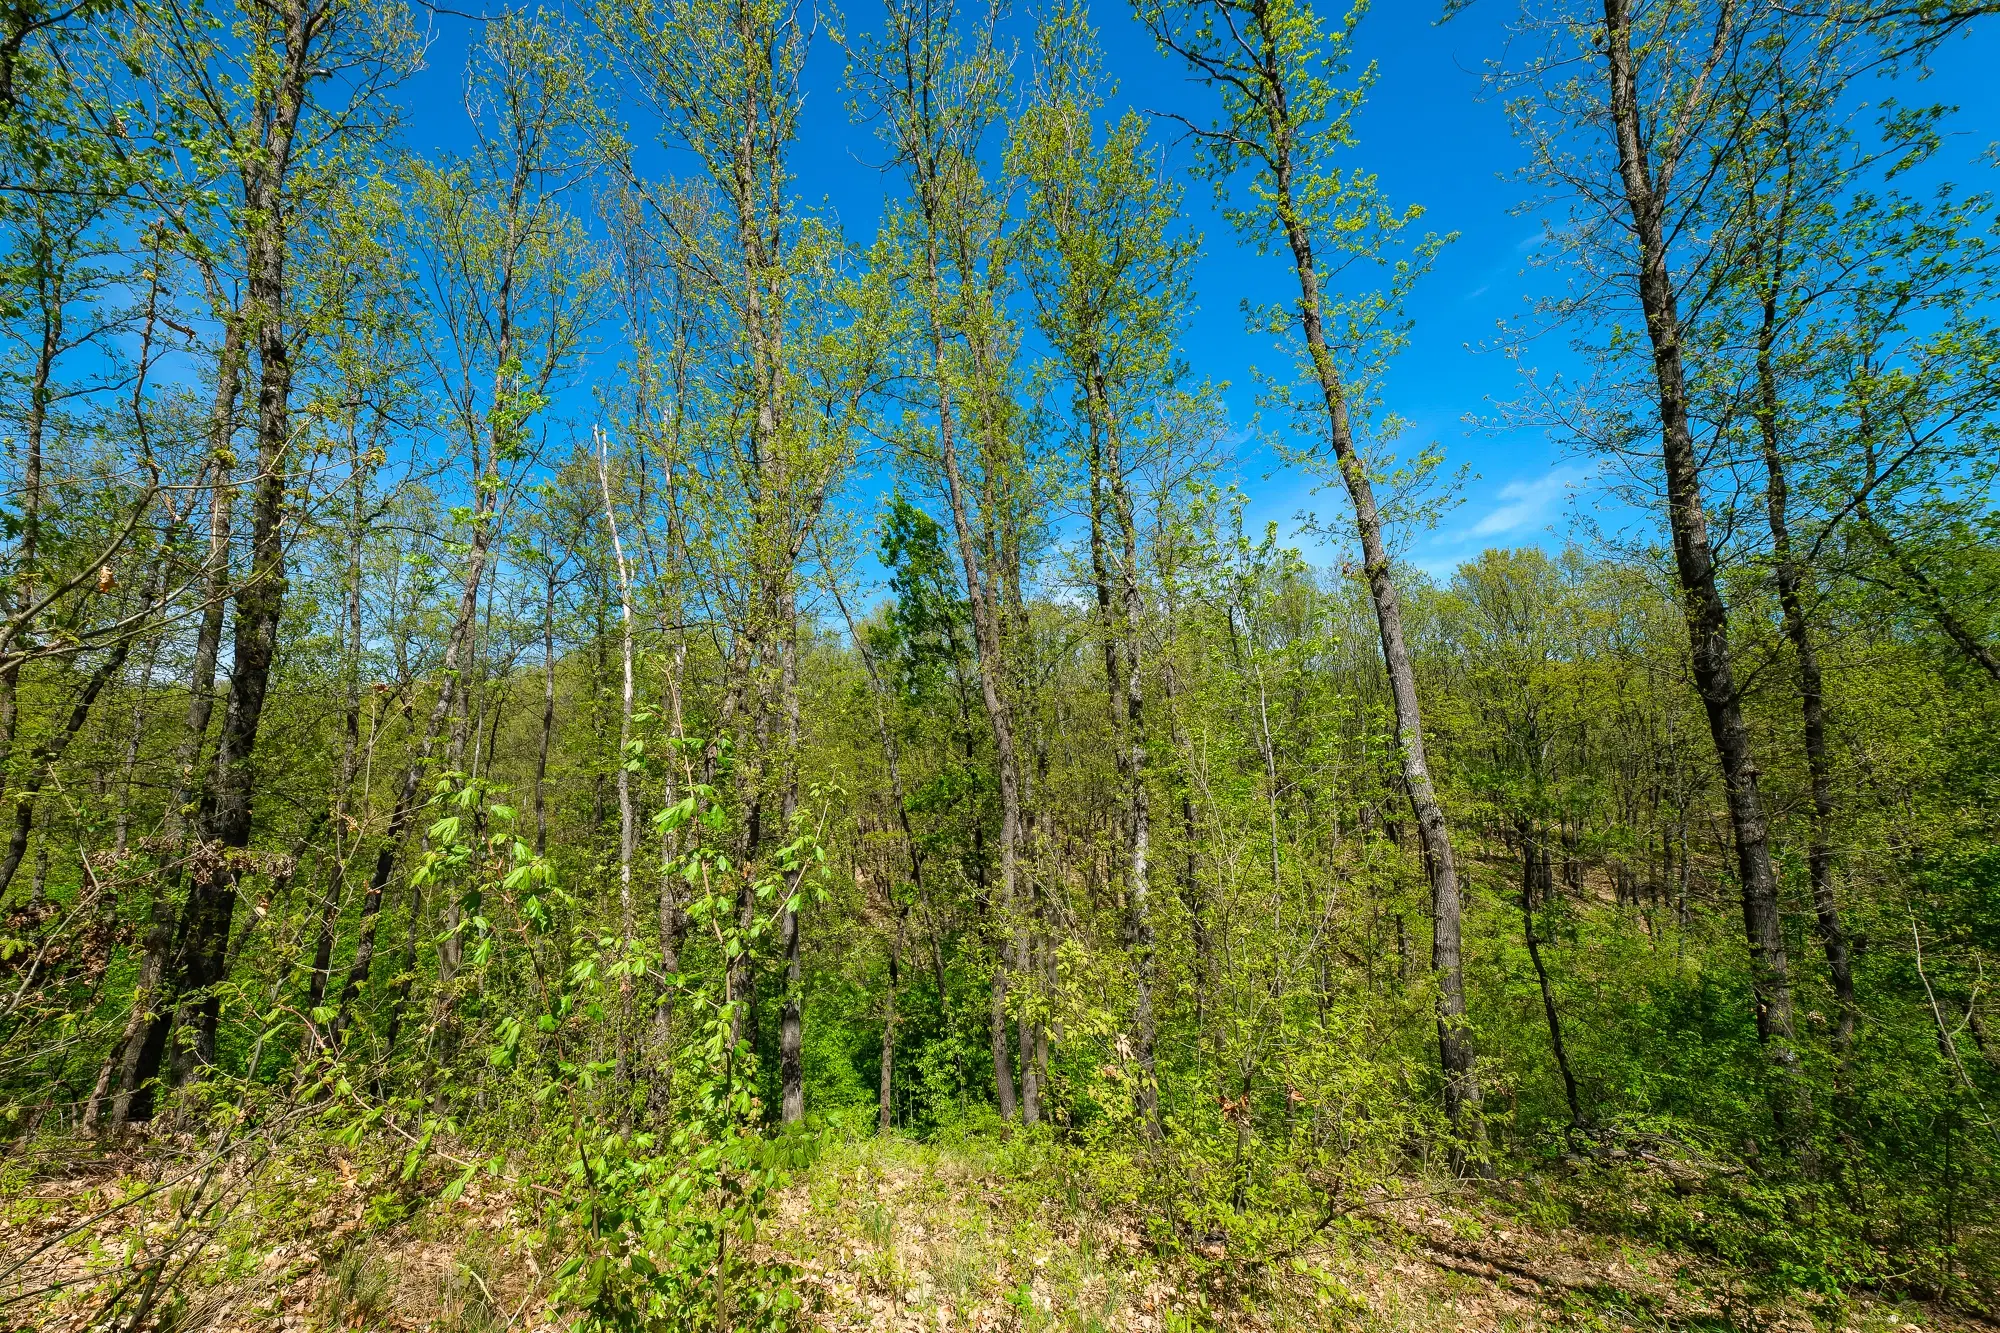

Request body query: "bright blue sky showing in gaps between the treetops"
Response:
[408, 0, 2000, 574]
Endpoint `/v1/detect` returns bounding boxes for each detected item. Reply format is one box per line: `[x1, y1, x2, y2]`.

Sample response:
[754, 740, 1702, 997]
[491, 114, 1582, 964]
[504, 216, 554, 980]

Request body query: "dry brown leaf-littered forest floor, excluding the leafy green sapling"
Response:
[0, 1139, 1992, 1333]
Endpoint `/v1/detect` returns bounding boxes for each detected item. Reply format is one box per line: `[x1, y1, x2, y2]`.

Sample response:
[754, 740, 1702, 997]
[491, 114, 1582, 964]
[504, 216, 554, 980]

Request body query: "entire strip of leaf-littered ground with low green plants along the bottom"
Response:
[0, 1125, 1976, 1333]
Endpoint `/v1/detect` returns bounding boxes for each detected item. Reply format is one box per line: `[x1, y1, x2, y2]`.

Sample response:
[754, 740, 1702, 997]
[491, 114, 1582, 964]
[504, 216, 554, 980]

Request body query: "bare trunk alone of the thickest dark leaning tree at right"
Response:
[1604, 0, 1808, 1133]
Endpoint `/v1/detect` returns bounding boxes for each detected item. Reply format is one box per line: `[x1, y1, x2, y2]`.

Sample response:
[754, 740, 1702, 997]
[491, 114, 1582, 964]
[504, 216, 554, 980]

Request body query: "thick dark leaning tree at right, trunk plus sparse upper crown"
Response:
[1514, 0, 1810, 1135]
